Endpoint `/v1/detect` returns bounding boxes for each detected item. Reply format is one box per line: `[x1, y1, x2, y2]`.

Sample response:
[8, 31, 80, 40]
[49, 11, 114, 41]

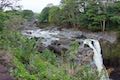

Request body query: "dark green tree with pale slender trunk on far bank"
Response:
[79, 0, 109, 32]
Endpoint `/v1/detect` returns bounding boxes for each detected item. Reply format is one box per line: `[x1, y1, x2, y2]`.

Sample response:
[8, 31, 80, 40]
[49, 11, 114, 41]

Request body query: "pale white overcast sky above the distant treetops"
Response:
[20, 0, 60, 12]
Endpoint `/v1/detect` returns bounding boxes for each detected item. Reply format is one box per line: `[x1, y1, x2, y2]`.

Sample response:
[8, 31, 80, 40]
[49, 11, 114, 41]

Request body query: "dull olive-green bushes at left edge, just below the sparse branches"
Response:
[0, 10, 26, 30]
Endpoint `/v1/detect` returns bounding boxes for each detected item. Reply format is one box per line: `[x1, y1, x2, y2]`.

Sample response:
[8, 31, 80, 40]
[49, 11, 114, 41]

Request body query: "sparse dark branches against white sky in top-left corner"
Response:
[0, 0, 20, 10]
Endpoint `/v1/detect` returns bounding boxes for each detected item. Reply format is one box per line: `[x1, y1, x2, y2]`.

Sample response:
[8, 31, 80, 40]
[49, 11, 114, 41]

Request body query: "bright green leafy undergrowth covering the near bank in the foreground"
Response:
[0, 30, 100, 80]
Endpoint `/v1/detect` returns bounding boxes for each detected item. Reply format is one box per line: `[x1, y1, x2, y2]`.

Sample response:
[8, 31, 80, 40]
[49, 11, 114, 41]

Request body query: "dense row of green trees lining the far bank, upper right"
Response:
[39, 0, 120, 31]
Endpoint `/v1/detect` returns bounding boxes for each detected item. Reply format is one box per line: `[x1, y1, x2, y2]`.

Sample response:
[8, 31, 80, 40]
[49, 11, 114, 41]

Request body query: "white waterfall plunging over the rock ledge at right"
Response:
[83, 39, 109, 80]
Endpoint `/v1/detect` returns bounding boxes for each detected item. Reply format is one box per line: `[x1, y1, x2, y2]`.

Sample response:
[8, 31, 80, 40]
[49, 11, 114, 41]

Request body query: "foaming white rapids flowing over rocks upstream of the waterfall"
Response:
[22, 29, 59, 46]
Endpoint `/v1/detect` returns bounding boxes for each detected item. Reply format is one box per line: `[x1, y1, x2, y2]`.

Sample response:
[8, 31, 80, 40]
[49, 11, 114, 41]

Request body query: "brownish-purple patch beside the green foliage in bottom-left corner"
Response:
[0, 50, 14, 80]
